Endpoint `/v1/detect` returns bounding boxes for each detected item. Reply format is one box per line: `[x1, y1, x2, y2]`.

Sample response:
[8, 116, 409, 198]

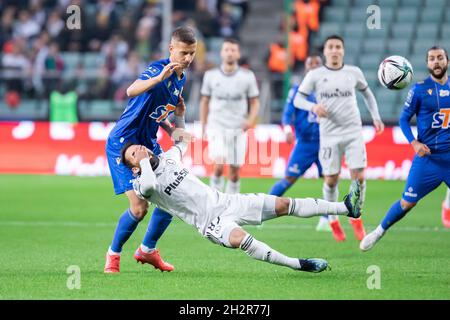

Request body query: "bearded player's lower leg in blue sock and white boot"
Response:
[359, 200, 416, 251]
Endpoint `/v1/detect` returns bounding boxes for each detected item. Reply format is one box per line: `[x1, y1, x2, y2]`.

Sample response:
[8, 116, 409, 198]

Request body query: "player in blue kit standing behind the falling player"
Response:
[104, 27, 197, 273]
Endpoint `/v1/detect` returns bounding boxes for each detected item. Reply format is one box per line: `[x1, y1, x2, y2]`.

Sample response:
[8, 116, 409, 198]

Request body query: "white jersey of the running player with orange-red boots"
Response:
[299, 65, 368, 136]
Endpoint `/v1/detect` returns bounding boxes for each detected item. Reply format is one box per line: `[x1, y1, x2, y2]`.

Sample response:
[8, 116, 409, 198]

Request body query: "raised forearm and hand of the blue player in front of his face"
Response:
[127, 62, 180, 98]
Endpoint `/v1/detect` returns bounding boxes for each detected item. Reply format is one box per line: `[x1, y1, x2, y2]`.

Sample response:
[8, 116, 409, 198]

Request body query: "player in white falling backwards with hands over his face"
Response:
[122, 132, 360, 272]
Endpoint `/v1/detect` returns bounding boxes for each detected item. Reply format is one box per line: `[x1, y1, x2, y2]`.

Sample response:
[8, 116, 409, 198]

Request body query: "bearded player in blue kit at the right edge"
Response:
[360, 46, 450, 251]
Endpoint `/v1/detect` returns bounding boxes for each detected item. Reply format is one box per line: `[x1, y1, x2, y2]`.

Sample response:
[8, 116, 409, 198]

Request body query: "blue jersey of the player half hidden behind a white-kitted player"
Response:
[282, 85, 319, 142]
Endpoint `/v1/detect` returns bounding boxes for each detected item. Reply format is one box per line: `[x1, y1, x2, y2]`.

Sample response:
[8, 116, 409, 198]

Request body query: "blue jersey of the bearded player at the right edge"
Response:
[401, 76, 450, 154]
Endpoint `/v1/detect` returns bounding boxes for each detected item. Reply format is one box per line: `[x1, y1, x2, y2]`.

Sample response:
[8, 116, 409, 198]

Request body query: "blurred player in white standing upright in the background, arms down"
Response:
[200, 39, 259, 193]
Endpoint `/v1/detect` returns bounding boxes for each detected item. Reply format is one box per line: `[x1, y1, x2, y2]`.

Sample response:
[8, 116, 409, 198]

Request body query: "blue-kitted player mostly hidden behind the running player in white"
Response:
[269, 54, 331, 231]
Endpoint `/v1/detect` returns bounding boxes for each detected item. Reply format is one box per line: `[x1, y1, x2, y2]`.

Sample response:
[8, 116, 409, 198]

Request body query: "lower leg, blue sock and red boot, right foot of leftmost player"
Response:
[134, 208, 175, 272]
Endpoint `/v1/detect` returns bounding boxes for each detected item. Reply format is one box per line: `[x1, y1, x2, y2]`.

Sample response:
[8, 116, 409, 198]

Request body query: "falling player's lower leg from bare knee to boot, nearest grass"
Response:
[230, 227, 328, 273]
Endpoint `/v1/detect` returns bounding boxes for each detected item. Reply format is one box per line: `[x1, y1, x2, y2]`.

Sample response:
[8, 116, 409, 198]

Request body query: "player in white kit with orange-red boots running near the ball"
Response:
[294, 35, 384, 241]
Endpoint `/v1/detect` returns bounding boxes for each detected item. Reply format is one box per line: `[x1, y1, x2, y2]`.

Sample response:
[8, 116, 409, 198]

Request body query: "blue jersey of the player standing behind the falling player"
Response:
[109, 59, 186, 150]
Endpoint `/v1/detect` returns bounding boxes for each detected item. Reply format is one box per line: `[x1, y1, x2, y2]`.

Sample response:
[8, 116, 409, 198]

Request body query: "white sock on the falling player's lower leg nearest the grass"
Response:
[239, 234, 300, 270]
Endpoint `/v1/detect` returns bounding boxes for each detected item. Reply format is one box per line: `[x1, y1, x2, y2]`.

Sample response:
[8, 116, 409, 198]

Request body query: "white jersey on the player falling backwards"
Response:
[133, 146, 230, 234]
